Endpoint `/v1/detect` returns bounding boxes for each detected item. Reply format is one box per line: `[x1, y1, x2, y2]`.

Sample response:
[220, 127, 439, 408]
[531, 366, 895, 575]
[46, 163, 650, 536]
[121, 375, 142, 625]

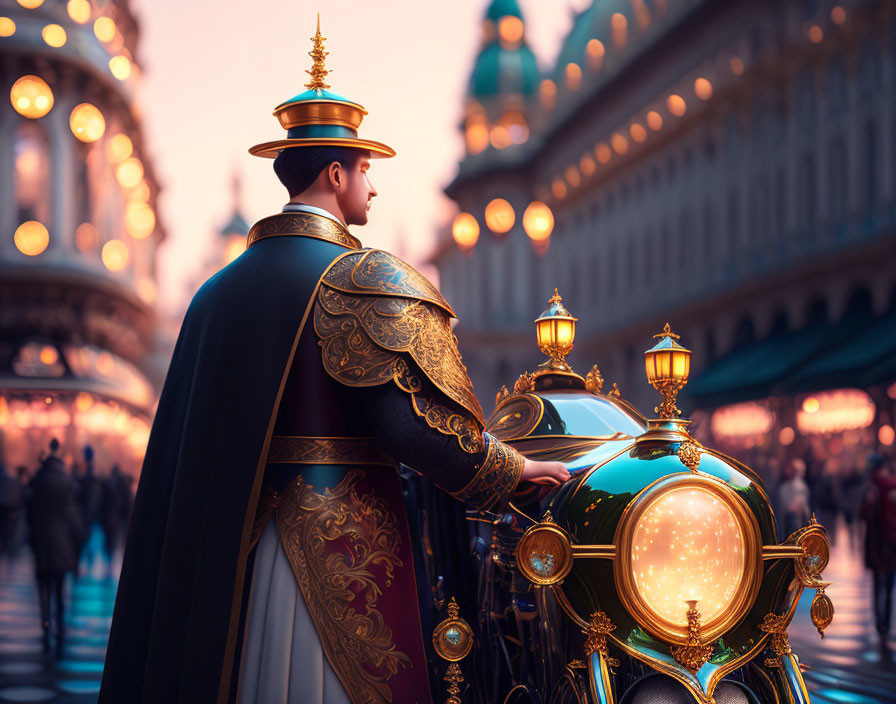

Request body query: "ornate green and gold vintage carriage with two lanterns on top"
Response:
[428, 294, 833, 704]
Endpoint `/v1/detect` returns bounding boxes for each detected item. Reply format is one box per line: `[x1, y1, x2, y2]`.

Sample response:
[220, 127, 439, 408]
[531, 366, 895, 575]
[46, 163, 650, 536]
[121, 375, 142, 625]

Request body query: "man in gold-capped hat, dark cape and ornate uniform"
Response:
[100, 19, 568, 704]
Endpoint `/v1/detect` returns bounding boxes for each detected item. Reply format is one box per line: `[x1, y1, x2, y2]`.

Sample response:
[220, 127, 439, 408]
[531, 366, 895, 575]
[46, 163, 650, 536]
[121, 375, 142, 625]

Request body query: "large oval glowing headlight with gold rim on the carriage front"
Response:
[613, 474, 762, 644]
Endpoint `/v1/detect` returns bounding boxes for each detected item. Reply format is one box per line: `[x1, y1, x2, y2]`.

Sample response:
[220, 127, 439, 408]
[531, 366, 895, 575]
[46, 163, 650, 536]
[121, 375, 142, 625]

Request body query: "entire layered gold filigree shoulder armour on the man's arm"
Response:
[314, 252, 485, 453]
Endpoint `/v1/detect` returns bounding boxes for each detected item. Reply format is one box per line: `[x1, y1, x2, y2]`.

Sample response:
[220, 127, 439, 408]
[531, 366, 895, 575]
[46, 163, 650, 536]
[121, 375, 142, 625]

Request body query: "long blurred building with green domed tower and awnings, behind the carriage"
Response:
[434, 0, 896, 468]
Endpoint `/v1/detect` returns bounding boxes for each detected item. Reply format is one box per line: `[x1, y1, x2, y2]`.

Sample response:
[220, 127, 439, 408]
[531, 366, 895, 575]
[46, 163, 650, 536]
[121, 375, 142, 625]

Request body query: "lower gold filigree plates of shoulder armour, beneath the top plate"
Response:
[314, 284, 485, 429]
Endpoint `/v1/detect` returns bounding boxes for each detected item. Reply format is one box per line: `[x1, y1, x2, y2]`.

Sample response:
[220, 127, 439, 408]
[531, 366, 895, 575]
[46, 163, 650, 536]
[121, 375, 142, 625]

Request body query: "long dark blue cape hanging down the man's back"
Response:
[99, 236, 346, 704]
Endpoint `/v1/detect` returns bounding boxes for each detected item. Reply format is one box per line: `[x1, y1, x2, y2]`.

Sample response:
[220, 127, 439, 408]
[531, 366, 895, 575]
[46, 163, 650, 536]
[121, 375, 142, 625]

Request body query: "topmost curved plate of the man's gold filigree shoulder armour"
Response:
[324, 249, 457, 318]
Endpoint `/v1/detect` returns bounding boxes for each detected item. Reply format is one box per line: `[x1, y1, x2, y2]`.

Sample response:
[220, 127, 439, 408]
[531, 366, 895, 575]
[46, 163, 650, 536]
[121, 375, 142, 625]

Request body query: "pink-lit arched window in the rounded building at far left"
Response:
[13, 120, 51, 225]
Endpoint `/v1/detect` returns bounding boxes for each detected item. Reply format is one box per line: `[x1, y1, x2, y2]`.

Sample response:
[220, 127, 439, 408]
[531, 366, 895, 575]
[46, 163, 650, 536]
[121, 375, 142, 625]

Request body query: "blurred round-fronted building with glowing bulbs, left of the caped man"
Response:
[0, 0, 167, 471]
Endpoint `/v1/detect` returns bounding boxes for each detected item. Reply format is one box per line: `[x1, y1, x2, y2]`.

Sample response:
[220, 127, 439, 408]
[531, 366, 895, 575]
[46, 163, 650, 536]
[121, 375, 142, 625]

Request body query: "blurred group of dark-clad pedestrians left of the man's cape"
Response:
[0, 438, 133, 652]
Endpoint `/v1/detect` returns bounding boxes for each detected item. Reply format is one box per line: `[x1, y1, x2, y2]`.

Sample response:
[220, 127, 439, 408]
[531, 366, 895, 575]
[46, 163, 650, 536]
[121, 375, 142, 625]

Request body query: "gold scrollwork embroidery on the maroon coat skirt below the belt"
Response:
[277, 470, 411, 704]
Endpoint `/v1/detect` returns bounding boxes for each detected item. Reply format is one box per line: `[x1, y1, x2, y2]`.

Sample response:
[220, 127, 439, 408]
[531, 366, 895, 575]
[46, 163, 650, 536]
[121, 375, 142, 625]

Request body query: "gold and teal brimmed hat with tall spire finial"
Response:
[249, 15, 395, 159]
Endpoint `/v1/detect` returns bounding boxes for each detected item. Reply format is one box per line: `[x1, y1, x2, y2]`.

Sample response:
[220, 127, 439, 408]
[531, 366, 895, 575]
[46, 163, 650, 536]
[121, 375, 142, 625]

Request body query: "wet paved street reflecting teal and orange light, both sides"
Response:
[0, 526, 896, 704]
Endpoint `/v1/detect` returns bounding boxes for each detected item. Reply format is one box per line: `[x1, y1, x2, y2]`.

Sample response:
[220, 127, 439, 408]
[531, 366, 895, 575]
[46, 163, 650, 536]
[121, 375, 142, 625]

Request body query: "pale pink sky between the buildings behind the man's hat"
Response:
[134, 0, 587, 310]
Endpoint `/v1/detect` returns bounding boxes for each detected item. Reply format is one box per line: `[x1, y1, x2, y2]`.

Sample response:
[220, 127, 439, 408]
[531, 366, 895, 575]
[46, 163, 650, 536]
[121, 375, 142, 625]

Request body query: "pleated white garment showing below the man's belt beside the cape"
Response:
[237, 517, 350, 704]
